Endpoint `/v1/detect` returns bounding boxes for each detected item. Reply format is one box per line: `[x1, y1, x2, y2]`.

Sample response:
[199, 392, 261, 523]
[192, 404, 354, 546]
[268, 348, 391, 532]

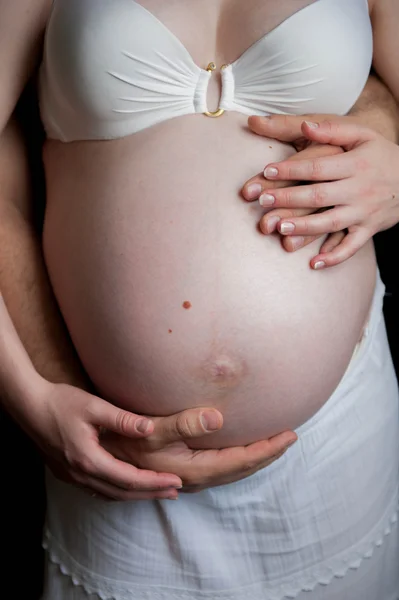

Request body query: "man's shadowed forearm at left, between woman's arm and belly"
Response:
[0, 116, 87, 386]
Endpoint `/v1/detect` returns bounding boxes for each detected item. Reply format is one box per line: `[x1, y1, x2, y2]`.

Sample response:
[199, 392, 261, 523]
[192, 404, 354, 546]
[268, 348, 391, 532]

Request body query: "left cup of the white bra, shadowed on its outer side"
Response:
[40, 0, 210, 140]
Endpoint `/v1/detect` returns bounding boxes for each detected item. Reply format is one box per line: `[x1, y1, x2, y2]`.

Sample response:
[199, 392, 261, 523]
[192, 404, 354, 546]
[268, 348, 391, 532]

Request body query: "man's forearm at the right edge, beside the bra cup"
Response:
[348, 75, 399, 143]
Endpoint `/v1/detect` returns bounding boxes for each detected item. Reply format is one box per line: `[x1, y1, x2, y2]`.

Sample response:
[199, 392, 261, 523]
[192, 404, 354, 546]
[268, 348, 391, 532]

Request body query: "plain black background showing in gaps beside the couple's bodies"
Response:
[0, 89, 399, 600]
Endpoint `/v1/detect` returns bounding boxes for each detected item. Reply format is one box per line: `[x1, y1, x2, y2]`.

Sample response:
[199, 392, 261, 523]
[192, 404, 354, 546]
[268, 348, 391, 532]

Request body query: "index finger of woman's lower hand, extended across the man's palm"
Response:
[78, 441, 182, 491]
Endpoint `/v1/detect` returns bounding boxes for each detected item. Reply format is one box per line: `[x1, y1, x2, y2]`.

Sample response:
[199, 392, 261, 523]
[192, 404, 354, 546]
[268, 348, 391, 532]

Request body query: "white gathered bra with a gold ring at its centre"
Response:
[39, 0, 372, 142]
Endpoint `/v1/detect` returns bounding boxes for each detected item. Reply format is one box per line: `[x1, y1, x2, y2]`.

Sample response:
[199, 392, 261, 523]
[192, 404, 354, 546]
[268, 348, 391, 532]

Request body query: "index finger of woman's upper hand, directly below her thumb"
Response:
[264, 153, 353, 181]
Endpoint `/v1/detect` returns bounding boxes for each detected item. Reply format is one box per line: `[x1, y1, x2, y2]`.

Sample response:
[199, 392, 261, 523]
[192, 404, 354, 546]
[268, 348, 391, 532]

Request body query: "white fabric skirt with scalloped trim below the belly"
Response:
[43, 280, 399, 600]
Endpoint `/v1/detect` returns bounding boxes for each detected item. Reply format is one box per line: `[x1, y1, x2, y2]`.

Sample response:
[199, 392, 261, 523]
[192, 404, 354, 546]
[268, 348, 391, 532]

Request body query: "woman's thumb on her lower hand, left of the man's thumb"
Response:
[90, 398, 154, 438]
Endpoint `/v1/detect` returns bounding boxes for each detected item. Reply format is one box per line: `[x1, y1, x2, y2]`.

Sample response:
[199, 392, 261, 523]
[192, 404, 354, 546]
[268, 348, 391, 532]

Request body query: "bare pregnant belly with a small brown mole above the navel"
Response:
[44, 117, 375, 446]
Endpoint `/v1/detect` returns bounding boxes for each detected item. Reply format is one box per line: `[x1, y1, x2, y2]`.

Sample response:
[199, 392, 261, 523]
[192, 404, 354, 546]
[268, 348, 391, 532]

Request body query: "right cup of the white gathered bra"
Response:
[221, 0, 373, 115]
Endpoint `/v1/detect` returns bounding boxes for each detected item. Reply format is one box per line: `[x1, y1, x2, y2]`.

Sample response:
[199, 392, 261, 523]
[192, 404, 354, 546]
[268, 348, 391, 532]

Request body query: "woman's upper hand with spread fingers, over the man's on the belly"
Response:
[245, 116, 399, 269]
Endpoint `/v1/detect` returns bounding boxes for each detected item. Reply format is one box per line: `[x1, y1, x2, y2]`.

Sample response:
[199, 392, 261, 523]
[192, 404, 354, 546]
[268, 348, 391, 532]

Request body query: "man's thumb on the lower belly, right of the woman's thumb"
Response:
[153, 408, 223, 445]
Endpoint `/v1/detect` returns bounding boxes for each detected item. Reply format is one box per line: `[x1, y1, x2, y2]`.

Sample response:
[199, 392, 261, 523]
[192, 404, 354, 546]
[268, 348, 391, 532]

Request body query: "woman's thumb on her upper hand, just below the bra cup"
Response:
[301, 118, 378, 150]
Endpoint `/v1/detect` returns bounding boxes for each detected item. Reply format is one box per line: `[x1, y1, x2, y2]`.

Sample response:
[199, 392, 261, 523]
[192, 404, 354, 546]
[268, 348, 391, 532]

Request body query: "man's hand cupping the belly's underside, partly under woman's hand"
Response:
[101, 409, 297, 500]
